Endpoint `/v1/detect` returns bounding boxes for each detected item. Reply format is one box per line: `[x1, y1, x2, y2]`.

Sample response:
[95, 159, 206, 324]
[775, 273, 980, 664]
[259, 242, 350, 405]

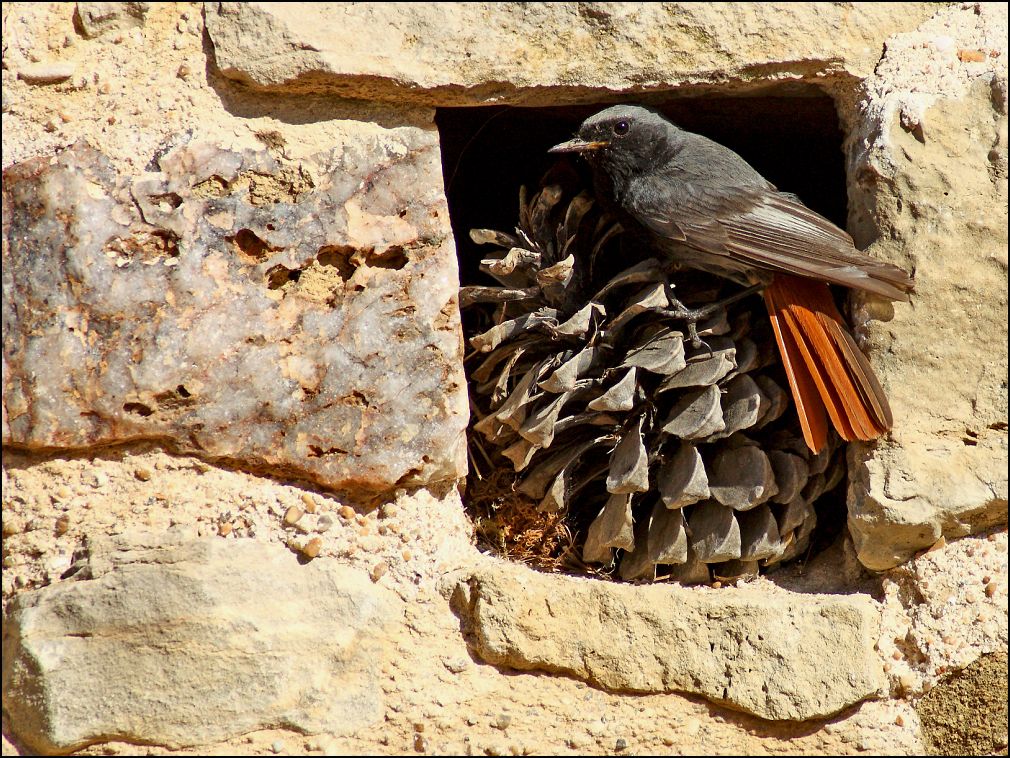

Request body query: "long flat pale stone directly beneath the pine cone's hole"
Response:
[461, 567, 885, 721]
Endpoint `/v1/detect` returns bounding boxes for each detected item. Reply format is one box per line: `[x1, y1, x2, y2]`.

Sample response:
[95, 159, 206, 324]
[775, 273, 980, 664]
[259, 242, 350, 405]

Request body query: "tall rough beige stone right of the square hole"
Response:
[848, 4, 1007, 569]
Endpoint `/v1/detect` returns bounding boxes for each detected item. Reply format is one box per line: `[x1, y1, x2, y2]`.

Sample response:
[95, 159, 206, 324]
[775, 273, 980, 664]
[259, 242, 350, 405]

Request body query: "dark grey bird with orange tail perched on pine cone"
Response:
[548, 105, 914, 454]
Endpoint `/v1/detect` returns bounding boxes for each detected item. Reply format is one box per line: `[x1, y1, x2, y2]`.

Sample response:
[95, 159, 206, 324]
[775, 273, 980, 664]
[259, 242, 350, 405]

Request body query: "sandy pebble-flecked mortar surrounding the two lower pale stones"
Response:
[3, 446, 1007, 755]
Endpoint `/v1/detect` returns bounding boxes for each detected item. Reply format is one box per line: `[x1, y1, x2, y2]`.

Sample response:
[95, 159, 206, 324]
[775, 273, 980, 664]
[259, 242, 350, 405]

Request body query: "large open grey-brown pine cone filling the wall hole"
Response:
[461, 174, 844, 583]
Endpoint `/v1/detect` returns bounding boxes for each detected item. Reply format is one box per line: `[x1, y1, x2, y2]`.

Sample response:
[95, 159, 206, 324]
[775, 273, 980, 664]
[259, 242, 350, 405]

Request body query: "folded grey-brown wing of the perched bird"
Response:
[635, 182, 912, 300]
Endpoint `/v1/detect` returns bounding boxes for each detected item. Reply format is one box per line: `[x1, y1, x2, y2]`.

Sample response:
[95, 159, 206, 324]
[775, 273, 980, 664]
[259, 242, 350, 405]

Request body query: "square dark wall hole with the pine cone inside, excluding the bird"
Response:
[435, 90, 860, 583]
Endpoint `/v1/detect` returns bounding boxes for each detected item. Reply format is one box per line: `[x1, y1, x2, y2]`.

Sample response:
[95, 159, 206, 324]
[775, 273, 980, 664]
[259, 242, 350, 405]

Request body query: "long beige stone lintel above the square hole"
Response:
[205, 3, 935, 105]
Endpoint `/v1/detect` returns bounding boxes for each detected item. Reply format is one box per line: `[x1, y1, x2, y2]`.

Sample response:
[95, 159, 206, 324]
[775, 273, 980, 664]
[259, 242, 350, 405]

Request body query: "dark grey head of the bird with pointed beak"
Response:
[547, 105, 683, 180]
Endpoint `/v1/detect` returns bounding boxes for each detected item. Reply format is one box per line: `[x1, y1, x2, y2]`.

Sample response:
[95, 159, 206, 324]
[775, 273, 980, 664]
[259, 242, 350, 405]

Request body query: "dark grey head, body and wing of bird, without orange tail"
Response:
[554, 105, 912, 300]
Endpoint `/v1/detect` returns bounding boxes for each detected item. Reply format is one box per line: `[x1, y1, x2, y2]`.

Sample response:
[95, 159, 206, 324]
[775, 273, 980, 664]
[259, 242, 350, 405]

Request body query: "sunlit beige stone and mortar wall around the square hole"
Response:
[2, 3, 1007, 754]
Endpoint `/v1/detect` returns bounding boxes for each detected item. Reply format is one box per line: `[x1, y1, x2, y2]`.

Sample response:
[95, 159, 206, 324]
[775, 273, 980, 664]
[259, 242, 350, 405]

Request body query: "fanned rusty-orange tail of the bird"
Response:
[765, 275, 892, 453]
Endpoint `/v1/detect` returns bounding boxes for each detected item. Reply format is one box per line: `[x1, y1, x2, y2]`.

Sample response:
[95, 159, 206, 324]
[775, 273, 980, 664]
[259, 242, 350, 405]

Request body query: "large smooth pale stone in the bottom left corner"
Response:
[3, 532, 402, 752]
